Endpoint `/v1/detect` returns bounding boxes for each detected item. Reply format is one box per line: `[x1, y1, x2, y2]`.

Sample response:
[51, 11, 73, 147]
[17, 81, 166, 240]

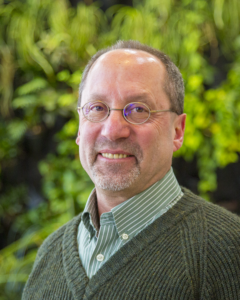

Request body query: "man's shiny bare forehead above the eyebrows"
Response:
[82, 49, 168, 106]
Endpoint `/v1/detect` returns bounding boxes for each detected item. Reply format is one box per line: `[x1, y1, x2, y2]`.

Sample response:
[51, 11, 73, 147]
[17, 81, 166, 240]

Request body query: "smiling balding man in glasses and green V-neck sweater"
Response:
[23, 41, 240, 300]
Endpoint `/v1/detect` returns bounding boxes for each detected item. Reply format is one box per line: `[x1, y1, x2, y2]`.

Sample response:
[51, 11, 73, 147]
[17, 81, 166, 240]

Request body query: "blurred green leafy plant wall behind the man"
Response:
[0, 0, 240, 300]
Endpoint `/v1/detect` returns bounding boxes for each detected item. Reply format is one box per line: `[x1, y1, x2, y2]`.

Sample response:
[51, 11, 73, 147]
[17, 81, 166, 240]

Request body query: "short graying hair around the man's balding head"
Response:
[78, 40, 184, 115]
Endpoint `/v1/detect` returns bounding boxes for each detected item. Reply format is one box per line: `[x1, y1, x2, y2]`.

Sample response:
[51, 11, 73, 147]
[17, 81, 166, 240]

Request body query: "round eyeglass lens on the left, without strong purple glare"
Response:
[83, 102, 109, 122]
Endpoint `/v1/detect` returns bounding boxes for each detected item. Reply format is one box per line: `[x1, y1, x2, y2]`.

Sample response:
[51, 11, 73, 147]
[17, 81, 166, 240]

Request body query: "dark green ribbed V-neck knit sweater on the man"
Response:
[22, 189, 240, 300]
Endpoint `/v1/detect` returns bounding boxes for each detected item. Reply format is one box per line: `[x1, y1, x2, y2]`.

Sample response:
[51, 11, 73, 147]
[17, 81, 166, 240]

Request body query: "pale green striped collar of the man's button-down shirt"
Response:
[82, 168, 181, 238]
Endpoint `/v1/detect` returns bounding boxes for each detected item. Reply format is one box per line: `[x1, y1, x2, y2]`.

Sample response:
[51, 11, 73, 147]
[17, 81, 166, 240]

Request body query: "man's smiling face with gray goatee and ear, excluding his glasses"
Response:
[77, 49, 185, 194]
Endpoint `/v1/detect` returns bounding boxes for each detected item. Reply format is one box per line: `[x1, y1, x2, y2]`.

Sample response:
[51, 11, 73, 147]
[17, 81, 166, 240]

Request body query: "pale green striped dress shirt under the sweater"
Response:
[78, 168, 183, 278]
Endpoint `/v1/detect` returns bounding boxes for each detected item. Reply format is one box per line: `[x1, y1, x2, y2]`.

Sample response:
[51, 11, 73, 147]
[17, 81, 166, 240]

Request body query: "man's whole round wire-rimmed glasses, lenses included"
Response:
[77, 101, 175, 125]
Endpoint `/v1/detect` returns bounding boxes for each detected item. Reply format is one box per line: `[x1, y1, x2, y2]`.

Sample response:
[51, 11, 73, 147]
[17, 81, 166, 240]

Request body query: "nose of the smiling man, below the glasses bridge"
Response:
[101, 110, 131, 141]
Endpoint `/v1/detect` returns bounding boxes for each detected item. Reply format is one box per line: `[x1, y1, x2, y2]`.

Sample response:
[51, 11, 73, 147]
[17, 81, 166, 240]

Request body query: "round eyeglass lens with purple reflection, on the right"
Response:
[123, 102, 150, 124]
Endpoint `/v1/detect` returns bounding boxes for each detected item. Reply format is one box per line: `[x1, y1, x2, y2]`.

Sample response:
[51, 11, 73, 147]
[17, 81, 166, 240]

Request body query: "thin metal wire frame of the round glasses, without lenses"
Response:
[77, 100, 178, 125]
